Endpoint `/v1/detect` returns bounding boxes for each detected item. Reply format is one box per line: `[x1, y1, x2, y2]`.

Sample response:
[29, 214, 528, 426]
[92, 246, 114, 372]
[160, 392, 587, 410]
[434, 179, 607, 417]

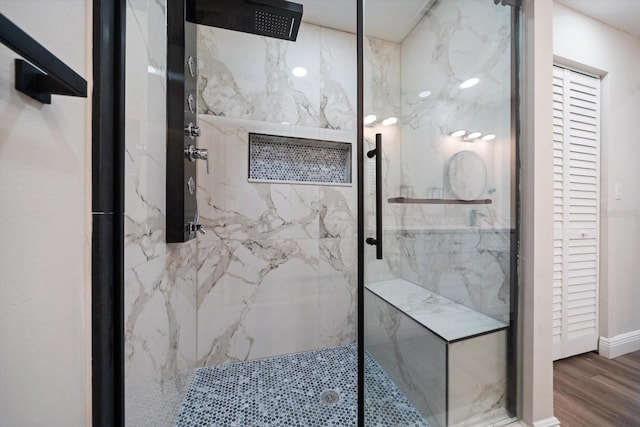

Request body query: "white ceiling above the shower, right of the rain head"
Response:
[294, 0, 433, 43]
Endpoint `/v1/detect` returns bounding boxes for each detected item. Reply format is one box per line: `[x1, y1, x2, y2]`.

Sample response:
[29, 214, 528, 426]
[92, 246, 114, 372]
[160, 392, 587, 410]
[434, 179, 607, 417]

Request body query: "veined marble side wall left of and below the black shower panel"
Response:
[124, 0, 197, 422]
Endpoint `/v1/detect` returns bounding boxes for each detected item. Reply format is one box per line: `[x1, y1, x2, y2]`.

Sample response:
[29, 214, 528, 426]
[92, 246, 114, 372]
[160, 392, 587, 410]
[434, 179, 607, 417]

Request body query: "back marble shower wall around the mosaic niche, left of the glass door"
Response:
[197, 23, 357, 366]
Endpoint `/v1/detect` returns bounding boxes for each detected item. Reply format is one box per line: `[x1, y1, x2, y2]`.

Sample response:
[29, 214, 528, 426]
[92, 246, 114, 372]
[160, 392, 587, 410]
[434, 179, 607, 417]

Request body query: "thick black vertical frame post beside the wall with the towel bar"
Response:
[91, 0, 126, 427]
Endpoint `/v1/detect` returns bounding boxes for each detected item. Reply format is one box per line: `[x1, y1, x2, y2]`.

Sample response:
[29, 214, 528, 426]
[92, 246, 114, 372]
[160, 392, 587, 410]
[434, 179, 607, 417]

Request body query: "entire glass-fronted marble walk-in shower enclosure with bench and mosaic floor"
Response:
[121, 0, 519, 427]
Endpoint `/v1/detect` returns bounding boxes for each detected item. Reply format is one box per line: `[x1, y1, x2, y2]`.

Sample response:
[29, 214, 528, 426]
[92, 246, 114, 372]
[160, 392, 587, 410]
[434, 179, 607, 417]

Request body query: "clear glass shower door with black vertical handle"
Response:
[362, 0, 518, 427]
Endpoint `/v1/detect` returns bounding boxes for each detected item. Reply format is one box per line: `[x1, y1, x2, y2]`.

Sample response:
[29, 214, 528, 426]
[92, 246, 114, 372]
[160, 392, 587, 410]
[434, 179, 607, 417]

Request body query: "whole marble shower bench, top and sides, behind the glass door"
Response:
[364, 279, 509, 427]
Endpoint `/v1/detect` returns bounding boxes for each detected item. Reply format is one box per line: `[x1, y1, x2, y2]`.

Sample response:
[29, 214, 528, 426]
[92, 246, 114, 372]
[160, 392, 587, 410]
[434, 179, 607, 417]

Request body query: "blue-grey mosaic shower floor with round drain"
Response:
[176, 344, 428, 427]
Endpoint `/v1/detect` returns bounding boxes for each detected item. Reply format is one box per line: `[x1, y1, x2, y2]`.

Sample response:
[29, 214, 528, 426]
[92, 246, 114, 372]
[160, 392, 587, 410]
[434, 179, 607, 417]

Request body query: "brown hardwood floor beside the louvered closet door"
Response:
[553, 351, 640, 427]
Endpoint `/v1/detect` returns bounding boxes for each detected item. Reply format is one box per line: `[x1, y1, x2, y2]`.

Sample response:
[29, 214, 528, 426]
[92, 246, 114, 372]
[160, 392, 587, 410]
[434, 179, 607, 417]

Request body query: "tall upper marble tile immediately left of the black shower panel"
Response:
[125, 0, 166, 269]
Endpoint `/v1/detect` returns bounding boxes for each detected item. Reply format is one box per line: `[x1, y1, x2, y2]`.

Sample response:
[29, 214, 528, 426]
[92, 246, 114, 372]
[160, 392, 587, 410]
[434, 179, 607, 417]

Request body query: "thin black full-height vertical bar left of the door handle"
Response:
[356, 0, 365, 427]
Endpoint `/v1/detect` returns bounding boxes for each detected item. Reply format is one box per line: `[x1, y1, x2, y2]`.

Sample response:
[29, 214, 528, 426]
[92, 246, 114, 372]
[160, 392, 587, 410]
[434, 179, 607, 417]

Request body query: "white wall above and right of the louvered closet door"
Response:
[553, 4, 640, 356]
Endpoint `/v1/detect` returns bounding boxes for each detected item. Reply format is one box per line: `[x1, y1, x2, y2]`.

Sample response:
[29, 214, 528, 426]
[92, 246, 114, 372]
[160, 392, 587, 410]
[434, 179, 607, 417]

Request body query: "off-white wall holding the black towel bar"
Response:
[0, 0, 91, 427]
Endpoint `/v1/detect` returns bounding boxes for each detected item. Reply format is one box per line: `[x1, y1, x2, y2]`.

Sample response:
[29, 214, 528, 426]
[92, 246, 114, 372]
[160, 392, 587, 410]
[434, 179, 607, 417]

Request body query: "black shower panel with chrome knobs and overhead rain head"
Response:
[166, 0, 302, 243]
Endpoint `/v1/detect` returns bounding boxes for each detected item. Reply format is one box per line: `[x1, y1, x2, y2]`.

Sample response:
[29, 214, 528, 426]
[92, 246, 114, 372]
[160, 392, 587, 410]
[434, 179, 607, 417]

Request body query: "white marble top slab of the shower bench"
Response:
[366, 279, 507, 343]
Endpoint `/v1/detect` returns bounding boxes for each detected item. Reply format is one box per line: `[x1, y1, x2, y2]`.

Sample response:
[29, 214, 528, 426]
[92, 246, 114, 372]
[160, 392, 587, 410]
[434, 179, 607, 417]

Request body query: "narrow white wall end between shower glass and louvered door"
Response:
[519, 0, 558, 427]
